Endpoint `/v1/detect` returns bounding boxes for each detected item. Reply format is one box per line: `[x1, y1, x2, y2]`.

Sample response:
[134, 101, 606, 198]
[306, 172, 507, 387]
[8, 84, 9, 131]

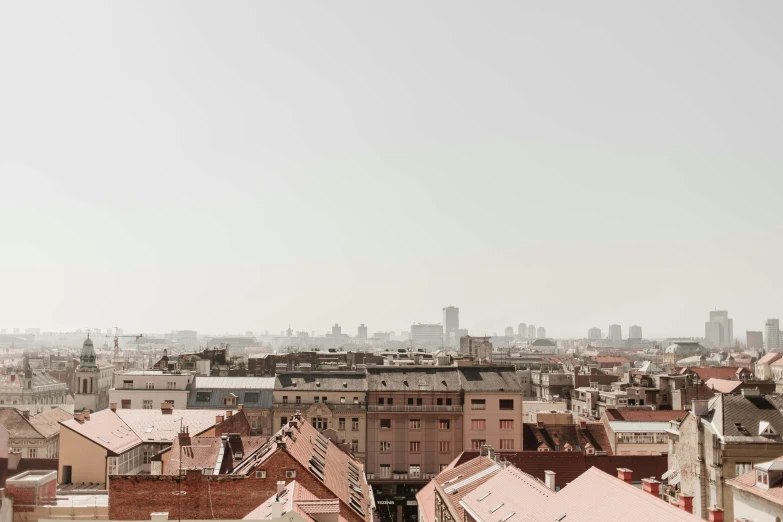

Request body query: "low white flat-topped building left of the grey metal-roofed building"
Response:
[109, 370, 196, 410]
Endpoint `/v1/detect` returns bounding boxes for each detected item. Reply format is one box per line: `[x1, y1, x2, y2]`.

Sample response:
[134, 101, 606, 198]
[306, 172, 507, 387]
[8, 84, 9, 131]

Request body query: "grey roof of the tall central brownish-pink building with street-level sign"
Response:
[367, 366, 461, 392]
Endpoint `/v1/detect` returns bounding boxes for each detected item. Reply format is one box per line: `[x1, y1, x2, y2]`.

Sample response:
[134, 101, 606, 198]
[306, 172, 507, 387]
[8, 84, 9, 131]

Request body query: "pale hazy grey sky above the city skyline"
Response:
[0, 0, 783, 337]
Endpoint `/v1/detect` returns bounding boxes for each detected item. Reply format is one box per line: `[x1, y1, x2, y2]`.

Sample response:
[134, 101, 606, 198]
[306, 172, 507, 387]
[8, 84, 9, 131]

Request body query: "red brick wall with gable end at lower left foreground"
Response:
[109, 442, 364, 522]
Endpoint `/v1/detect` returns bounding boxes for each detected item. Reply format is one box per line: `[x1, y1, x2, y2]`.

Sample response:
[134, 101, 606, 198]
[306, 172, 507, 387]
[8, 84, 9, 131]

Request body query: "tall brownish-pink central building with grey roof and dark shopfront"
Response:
[366, 366, 466, 520]
